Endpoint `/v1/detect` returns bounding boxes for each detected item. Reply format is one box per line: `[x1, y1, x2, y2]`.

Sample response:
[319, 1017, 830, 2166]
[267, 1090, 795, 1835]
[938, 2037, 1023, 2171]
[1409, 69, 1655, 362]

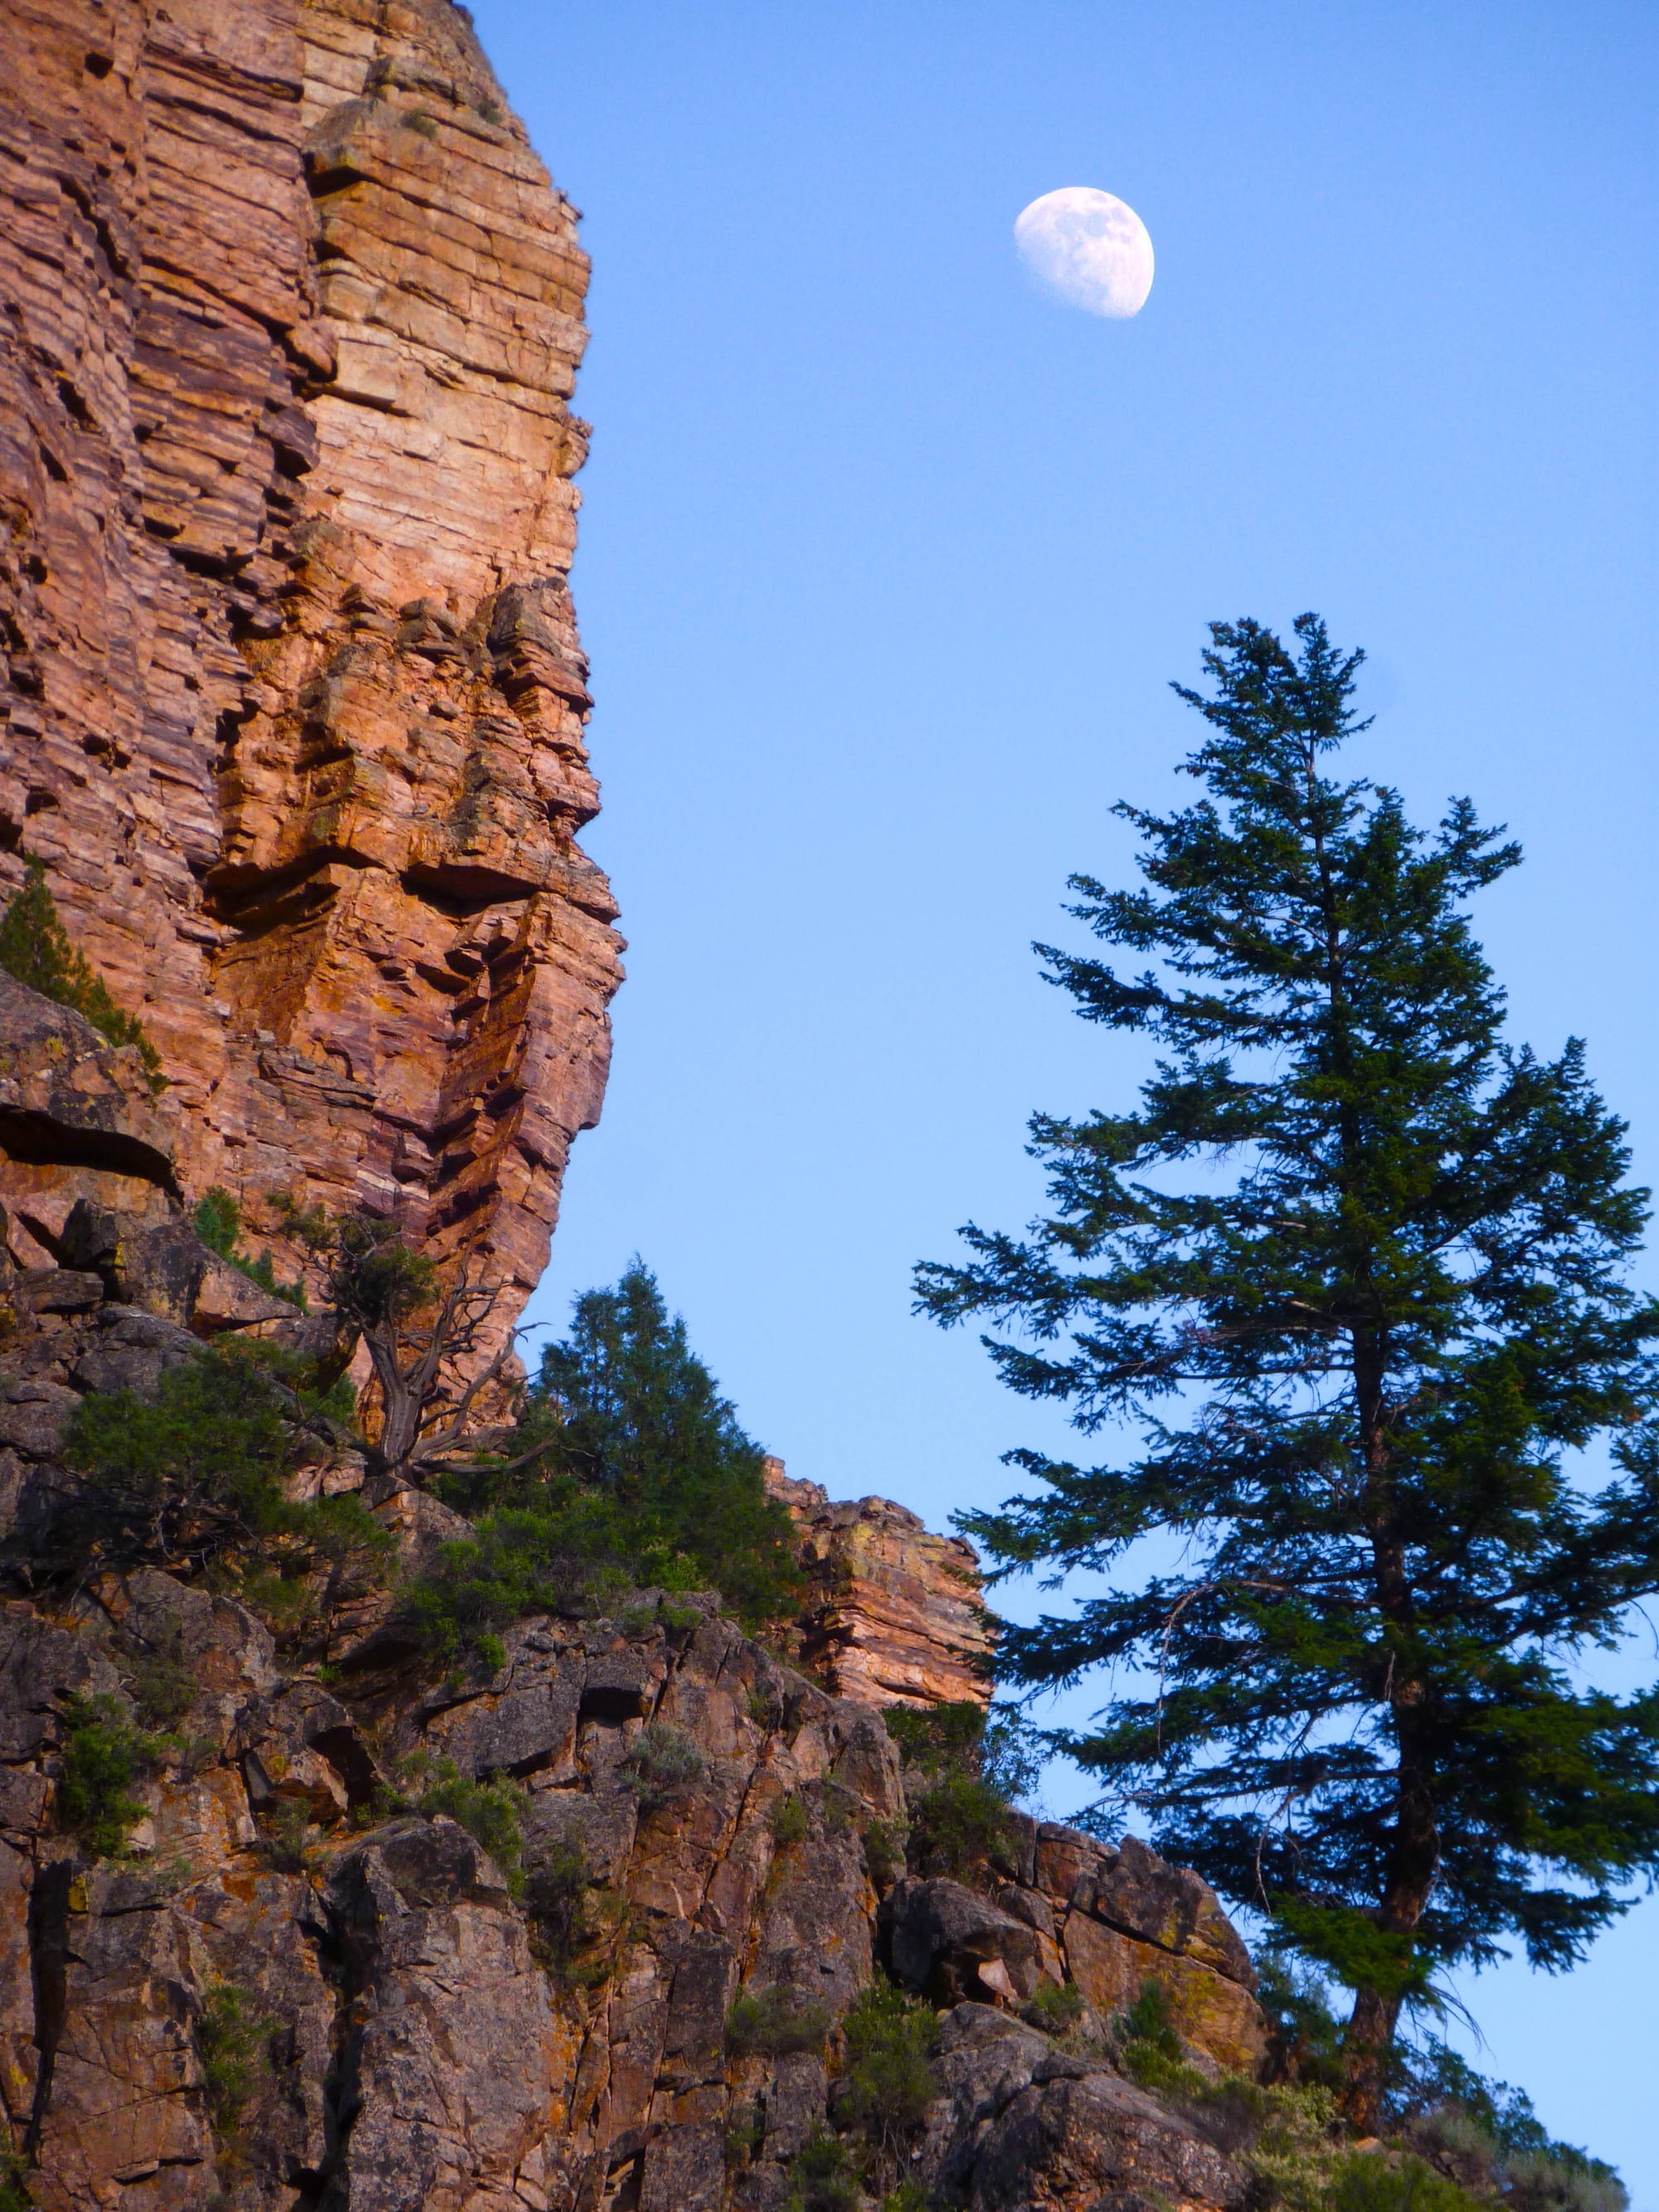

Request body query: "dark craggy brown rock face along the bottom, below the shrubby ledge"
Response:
[0, 1571, 1263, 2212]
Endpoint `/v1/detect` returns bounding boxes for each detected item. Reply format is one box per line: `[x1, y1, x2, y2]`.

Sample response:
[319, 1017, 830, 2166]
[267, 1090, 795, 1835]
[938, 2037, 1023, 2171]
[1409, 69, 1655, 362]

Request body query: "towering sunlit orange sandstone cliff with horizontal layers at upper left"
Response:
[0, 0, 620, 1327]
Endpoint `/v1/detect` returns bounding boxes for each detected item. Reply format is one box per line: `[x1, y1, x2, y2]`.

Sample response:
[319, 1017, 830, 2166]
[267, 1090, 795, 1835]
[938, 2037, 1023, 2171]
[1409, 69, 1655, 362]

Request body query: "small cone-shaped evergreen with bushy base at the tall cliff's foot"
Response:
[421, 1263, 799, 1637]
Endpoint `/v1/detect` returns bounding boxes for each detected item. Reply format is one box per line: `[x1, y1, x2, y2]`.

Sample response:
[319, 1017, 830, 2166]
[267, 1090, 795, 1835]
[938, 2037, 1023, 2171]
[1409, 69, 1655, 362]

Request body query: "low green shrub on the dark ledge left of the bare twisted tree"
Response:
[56, 1343, 389, 1617]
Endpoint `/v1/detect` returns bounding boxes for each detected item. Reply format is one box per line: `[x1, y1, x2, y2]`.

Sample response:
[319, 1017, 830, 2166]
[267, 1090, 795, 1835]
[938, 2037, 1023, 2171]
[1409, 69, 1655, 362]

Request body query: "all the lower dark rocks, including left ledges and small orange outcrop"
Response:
[0, 975, 1265, 2212]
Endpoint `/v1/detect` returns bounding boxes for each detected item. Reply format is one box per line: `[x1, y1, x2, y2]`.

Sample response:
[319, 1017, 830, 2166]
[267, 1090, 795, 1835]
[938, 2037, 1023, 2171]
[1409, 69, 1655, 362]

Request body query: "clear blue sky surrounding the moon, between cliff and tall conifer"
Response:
[475, 0, 1659, 2212]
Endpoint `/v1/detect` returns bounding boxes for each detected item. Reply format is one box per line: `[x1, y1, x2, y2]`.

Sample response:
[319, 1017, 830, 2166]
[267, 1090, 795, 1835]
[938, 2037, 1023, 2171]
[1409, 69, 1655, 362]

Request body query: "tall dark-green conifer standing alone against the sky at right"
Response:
[918, 615, 1659, 2126]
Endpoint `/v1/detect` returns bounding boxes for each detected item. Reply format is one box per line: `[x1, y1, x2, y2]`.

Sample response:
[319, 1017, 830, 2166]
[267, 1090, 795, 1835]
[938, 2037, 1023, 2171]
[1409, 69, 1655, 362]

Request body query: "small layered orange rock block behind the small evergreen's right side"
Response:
[766, 1460, 991, 1705]
